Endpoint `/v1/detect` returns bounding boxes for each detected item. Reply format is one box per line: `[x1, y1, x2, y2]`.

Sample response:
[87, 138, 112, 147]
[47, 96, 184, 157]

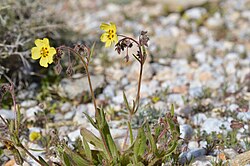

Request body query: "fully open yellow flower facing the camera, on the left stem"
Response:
[31, 38, 56, 67]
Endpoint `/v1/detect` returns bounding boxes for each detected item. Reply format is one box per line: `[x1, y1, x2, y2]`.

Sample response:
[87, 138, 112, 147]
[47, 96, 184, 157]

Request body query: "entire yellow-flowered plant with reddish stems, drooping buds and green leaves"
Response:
[0, 23, 180, 166]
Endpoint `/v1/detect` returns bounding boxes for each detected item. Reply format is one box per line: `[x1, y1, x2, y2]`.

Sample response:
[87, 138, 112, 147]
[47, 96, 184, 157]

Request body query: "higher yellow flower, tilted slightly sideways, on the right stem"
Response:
[100, 22, 118, 47]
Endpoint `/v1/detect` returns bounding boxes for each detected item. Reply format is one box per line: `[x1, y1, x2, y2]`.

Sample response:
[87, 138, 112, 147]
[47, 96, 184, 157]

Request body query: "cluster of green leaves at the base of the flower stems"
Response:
[58, 107, 180, 166]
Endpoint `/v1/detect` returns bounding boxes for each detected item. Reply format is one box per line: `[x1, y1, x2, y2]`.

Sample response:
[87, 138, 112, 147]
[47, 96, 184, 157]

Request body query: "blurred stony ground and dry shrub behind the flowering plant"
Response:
[0, 0, 250, 164]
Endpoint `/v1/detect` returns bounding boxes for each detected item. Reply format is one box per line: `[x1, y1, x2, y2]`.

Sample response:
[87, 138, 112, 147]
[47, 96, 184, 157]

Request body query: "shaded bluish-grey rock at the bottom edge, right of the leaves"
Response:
[179, 148, 207, 164]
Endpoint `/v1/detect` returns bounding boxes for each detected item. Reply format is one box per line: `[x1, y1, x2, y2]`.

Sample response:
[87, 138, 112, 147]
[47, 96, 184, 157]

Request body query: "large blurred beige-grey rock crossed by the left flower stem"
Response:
[58, 75, 105, 99]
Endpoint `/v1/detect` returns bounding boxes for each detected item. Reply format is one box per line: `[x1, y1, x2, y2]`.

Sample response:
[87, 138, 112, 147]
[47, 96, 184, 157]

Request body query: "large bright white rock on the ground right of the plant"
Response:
[201, 118, 231, 134]
